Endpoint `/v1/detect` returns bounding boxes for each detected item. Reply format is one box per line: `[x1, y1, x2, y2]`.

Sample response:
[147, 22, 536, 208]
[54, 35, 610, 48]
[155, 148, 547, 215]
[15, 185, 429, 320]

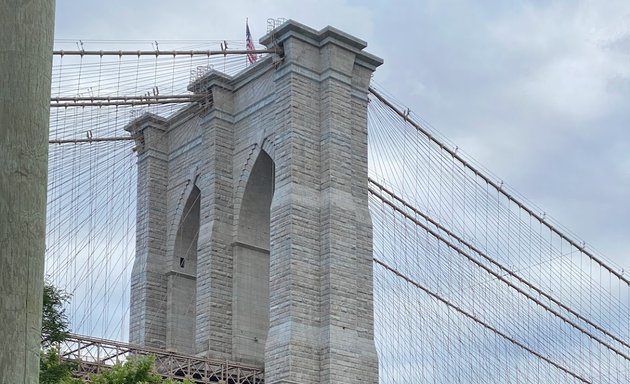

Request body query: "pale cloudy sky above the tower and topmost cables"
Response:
[55, 0, 630, 269]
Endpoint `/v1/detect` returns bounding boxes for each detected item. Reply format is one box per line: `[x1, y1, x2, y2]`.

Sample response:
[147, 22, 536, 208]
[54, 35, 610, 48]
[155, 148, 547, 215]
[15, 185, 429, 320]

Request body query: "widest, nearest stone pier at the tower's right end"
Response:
[263, 21, 382, 384]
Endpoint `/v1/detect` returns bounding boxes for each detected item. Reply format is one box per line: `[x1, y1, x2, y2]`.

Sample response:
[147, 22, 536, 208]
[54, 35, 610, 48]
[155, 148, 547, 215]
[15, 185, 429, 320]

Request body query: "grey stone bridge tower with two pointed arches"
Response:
[126, 21, 382, 383]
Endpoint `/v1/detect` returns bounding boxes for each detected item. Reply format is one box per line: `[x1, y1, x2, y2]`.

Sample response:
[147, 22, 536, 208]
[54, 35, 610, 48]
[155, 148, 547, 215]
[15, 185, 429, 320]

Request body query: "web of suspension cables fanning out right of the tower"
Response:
[368, 91, 630, 382]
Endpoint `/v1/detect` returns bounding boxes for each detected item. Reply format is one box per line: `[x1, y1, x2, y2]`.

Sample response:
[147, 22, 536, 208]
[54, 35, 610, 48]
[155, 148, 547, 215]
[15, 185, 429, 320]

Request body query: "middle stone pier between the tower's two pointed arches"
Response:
[195, 79, 234, 359]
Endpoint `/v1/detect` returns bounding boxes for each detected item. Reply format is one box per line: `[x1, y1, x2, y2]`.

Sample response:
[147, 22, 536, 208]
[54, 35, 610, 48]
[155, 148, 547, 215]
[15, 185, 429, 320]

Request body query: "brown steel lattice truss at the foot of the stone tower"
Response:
[59, 335, 264, 384]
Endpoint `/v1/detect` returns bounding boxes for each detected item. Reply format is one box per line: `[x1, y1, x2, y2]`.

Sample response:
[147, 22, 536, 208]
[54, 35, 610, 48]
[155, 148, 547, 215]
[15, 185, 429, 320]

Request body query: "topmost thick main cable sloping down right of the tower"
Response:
[369, 86, 630, 286]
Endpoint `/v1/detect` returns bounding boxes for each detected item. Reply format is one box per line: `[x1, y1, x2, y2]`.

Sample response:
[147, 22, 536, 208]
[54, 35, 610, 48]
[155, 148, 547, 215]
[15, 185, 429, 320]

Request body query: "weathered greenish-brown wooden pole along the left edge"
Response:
[0, 0, 55, 384]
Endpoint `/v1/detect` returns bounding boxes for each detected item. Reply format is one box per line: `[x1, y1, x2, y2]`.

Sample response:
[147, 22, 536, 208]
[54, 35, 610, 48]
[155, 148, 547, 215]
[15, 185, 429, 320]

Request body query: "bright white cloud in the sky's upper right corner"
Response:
[490, 2, 630, 122]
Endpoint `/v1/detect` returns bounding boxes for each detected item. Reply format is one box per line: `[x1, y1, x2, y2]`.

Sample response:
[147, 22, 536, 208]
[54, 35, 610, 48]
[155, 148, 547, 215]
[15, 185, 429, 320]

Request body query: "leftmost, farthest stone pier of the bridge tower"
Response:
[125, 114, 168, 348]
